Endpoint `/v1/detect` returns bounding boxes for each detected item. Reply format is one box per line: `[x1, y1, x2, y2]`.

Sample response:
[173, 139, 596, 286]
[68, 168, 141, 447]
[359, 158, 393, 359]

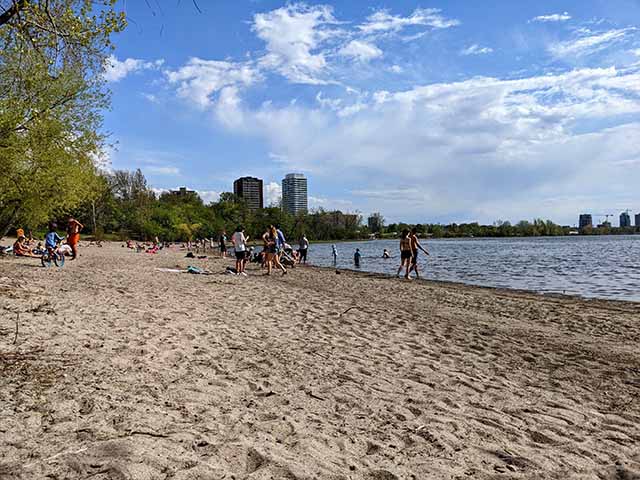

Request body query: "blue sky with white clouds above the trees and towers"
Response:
[104, 0, 640, 225]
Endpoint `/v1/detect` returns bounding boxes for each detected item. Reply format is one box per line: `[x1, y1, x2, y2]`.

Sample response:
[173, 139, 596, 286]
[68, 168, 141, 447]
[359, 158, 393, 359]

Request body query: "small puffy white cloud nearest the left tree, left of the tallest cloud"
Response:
[165, 58, 261, 108]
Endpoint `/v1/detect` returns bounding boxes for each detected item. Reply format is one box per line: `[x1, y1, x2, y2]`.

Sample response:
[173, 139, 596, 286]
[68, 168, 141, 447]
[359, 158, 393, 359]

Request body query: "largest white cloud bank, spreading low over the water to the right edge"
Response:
[204, 68, 640, 221]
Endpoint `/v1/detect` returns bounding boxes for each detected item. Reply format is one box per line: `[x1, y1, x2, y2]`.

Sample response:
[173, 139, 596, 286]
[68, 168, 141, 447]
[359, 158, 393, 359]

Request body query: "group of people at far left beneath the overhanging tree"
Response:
[5, 217, 84, 260]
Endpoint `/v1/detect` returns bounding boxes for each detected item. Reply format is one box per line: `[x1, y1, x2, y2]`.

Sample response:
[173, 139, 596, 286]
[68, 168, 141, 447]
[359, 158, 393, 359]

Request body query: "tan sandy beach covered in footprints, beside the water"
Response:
[0, 244, 640, 480]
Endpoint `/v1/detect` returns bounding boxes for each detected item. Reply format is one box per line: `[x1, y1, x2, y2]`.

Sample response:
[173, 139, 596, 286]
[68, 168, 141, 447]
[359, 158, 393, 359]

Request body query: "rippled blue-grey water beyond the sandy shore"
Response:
[302, 235, 640, 301]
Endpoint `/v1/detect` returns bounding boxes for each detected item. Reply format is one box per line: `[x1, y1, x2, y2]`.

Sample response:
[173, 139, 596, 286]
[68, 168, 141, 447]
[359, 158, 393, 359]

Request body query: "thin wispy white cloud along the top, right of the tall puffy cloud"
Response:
[358, 8, 460, 35]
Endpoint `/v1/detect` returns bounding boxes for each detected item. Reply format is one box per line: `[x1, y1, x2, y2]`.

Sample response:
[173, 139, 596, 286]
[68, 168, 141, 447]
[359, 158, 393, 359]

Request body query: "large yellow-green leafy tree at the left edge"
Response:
[0, 0, 125, 235]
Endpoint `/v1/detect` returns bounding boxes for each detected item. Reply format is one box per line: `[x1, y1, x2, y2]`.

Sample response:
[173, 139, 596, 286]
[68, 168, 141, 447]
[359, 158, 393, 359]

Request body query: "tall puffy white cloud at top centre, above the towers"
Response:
[252, 3, 340, 84]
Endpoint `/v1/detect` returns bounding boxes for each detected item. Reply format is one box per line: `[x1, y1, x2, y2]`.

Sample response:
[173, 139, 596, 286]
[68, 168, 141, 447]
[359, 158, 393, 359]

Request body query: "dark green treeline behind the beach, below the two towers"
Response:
[71, 170, 367, 242]
